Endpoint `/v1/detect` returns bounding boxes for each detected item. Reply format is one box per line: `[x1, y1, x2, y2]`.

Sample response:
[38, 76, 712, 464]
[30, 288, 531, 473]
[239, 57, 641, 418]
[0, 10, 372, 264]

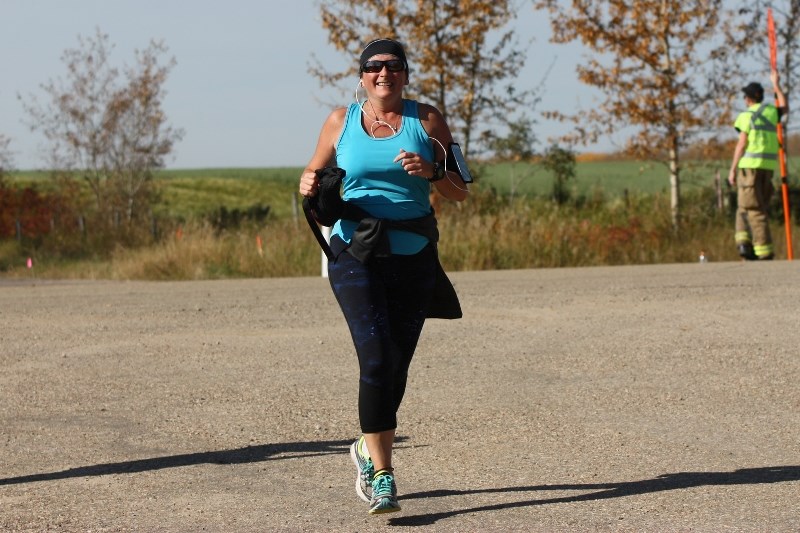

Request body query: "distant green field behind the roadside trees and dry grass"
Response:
[10, 158, 800, 220]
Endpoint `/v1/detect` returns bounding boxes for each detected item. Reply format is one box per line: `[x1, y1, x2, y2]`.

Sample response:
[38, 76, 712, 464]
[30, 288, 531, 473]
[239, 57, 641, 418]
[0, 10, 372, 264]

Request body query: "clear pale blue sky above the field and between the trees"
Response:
[0, 0, 600, 169]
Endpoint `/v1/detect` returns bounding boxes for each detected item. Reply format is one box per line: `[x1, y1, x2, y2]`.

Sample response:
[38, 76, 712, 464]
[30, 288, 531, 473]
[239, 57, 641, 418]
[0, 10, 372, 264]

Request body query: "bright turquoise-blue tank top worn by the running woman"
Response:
[331, 100, 433, 255]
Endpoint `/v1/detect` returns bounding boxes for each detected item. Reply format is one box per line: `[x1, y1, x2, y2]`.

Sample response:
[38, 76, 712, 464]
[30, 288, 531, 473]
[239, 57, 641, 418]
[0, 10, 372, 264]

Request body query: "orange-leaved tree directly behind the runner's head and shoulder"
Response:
[312, 0, 532, 158]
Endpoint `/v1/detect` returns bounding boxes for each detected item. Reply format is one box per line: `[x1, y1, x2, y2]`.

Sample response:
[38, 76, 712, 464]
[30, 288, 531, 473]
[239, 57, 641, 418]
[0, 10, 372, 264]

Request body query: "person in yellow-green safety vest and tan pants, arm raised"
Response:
[728, 70, 789, 260]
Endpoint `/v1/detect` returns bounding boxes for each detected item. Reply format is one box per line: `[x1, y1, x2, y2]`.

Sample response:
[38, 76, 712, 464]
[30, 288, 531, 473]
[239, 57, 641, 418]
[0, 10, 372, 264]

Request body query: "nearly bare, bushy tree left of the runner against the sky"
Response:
[19, 29, 183, 229]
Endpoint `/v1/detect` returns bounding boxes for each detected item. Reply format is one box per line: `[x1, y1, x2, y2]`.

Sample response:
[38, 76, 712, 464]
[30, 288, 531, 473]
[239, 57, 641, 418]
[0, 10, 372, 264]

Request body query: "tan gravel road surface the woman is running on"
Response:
[0, 261, 800, 532]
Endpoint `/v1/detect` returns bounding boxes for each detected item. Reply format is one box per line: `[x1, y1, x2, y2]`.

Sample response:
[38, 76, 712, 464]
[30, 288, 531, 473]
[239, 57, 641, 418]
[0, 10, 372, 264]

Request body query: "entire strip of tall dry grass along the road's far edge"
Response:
[0, 187, 800, 280]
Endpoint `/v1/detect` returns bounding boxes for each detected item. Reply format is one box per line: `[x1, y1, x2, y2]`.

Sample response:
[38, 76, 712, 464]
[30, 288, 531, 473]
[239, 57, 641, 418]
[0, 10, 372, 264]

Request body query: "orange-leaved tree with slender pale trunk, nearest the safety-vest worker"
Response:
[534, 0, 738, 231]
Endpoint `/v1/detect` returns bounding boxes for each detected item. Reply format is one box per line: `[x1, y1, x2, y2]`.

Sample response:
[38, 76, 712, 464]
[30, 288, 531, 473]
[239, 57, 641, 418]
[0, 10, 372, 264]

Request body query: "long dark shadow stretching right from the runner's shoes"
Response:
[389, 466, 800, 526]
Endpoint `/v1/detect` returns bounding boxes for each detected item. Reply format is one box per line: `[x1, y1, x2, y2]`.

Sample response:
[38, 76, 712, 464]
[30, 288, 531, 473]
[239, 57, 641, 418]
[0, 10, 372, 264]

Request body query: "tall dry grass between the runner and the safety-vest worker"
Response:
[440, 188, 748, 270]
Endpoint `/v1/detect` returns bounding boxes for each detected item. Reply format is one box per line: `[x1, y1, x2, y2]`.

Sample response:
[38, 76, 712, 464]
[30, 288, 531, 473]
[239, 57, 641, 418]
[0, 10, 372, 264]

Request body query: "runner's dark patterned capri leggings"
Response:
[328, 243, 436, 433]
